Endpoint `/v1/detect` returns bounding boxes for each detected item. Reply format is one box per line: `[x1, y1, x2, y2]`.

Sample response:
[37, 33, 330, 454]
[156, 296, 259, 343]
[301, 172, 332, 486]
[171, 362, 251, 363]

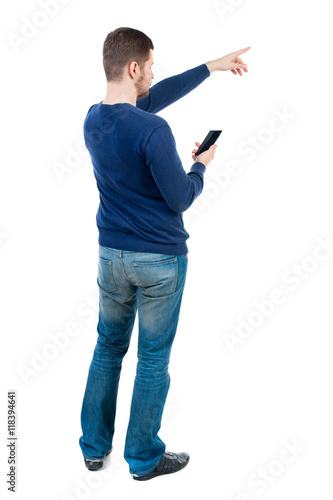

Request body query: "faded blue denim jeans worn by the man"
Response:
[79, 245, 188, 476]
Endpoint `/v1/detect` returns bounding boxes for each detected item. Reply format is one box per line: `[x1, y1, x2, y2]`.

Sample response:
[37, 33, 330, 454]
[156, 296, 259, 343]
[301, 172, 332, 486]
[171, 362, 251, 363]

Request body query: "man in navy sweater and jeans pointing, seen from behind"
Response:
[79, 28, 250, 481]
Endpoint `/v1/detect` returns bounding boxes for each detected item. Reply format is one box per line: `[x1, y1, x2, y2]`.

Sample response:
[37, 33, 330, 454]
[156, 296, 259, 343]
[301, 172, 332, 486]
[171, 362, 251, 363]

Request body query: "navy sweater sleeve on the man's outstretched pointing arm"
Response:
[136, 64, 210, 113]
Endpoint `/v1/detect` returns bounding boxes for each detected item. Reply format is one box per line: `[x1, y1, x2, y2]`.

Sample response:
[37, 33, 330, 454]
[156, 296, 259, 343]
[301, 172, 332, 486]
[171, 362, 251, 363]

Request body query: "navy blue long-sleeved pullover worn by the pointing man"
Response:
[83, 64, 210, 255]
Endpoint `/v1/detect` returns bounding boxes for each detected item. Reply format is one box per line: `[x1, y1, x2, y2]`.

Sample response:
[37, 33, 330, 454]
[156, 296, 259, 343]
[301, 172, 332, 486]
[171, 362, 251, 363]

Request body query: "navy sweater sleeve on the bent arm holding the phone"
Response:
[146, 125, 206, 213]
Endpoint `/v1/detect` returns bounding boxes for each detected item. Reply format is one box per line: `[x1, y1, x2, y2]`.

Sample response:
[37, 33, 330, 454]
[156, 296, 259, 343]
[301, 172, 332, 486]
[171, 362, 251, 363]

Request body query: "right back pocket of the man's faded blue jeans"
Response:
[132, 257, 178, 297]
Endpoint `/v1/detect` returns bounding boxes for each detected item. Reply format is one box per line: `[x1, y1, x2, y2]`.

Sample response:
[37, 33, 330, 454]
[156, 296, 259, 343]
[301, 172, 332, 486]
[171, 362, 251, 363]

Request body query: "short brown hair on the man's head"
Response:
[103, 28, 154, 82]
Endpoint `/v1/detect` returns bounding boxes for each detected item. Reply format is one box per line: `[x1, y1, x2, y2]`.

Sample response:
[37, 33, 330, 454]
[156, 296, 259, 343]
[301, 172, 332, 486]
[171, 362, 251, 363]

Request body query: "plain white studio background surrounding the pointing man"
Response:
[0, 0, 333, 500]
